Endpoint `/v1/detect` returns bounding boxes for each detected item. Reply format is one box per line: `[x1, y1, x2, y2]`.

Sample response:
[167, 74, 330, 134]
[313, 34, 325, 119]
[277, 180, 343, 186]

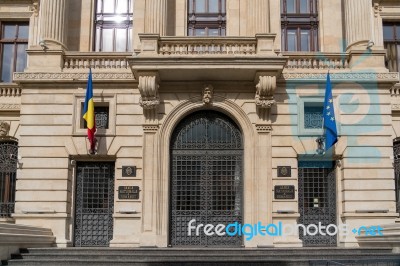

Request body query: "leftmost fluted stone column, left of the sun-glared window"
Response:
[40, 0, 69, 49]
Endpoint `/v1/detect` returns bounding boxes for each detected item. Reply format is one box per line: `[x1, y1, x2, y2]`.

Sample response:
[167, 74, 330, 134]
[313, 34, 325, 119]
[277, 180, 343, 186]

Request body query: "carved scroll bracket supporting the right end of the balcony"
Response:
[255, 76, 276, 108]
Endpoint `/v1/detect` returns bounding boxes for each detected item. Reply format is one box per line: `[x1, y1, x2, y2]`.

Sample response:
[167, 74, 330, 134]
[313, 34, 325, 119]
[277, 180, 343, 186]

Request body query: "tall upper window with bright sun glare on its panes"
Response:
[95, 0, 133, 52]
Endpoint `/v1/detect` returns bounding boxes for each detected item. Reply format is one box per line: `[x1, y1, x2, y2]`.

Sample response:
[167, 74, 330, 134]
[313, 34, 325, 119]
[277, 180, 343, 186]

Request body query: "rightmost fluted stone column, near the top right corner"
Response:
[344, 0, 372, 50]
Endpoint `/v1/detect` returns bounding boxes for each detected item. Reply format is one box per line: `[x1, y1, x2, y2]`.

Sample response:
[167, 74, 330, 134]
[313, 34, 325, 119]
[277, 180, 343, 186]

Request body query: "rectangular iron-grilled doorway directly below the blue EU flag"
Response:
[299, 162, 337, 247]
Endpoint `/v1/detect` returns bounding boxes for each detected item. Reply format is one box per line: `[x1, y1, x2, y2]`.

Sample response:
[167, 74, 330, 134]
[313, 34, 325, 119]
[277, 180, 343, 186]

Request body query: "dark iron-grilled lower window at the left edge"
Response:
[0, 141, 18, 218]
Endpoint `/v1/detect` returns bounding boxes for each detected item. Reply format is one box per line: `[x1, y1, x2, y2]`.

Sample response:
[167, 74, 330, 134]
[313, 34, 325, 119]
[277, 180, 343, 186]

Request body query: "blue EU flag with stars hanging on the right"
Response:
[322, 73, 337, 151]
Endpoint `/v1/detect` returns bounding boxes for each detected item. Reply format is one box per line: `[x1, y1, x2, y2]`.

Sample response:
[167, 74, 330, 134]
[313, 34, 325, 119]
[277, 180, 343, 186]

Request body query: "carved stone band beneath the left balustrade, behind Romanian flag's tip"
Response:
[14, 72, 135, 83]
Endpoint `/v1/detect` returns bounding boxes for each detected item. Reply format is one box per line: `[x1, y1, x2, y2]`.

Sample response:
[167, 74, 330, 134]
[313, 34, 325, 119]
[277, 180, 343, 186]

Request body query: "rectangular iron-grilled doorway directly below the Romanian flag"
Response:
[74, 162, 114, 247]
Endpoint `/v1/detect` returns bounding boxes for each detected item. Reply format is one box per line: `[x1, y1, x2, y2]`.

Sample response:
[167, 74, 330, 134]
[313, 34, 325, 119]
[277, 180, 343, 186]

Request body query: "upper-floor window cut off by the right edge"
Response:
[383, 22, 400, 72]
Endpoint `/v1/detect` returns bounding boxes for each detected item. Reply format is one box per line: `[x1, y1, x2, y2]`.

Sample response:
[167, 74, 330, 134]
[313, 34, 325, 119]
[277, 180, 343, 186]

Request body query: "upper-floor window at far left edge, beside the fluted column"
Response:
[0, 22, 29, 82]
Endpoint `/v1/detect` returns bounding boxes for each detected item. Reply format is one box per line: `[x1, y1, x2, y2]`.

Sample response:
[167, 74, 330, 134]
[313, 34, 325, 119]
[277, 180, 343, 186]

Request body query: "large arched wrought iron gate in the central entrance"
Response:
[170, 111, 243, 246]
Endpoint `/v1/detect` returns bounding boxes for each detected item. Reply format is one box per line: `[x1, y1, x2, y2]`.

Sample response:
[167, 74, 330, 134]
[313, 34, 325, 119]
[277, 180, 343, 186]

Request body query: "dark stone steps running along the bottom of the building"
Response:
[8, 248, 400, 266]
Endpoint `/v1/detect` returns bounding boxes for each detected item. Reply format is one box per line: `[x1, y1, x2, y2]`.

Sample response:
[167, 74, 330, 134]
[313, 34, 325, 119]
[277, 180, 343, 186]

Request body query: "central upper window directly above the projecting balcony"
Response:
[188, 0, 226, 36]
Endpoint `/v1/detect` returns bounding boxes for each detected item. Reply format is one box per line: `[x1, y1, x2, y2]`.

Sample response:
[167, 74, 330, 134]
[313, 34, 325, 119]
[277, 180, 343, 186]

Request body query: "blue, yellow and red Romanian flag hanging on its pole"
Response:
[82, 69, 96, 152]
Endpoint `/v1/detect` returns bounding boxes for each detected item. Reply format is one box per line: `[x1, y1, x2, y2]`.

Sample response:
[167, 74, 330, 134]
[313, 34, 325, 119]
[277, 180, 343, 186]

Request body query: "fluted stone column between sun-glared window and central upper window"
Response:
[144, 0, 167, 36]
